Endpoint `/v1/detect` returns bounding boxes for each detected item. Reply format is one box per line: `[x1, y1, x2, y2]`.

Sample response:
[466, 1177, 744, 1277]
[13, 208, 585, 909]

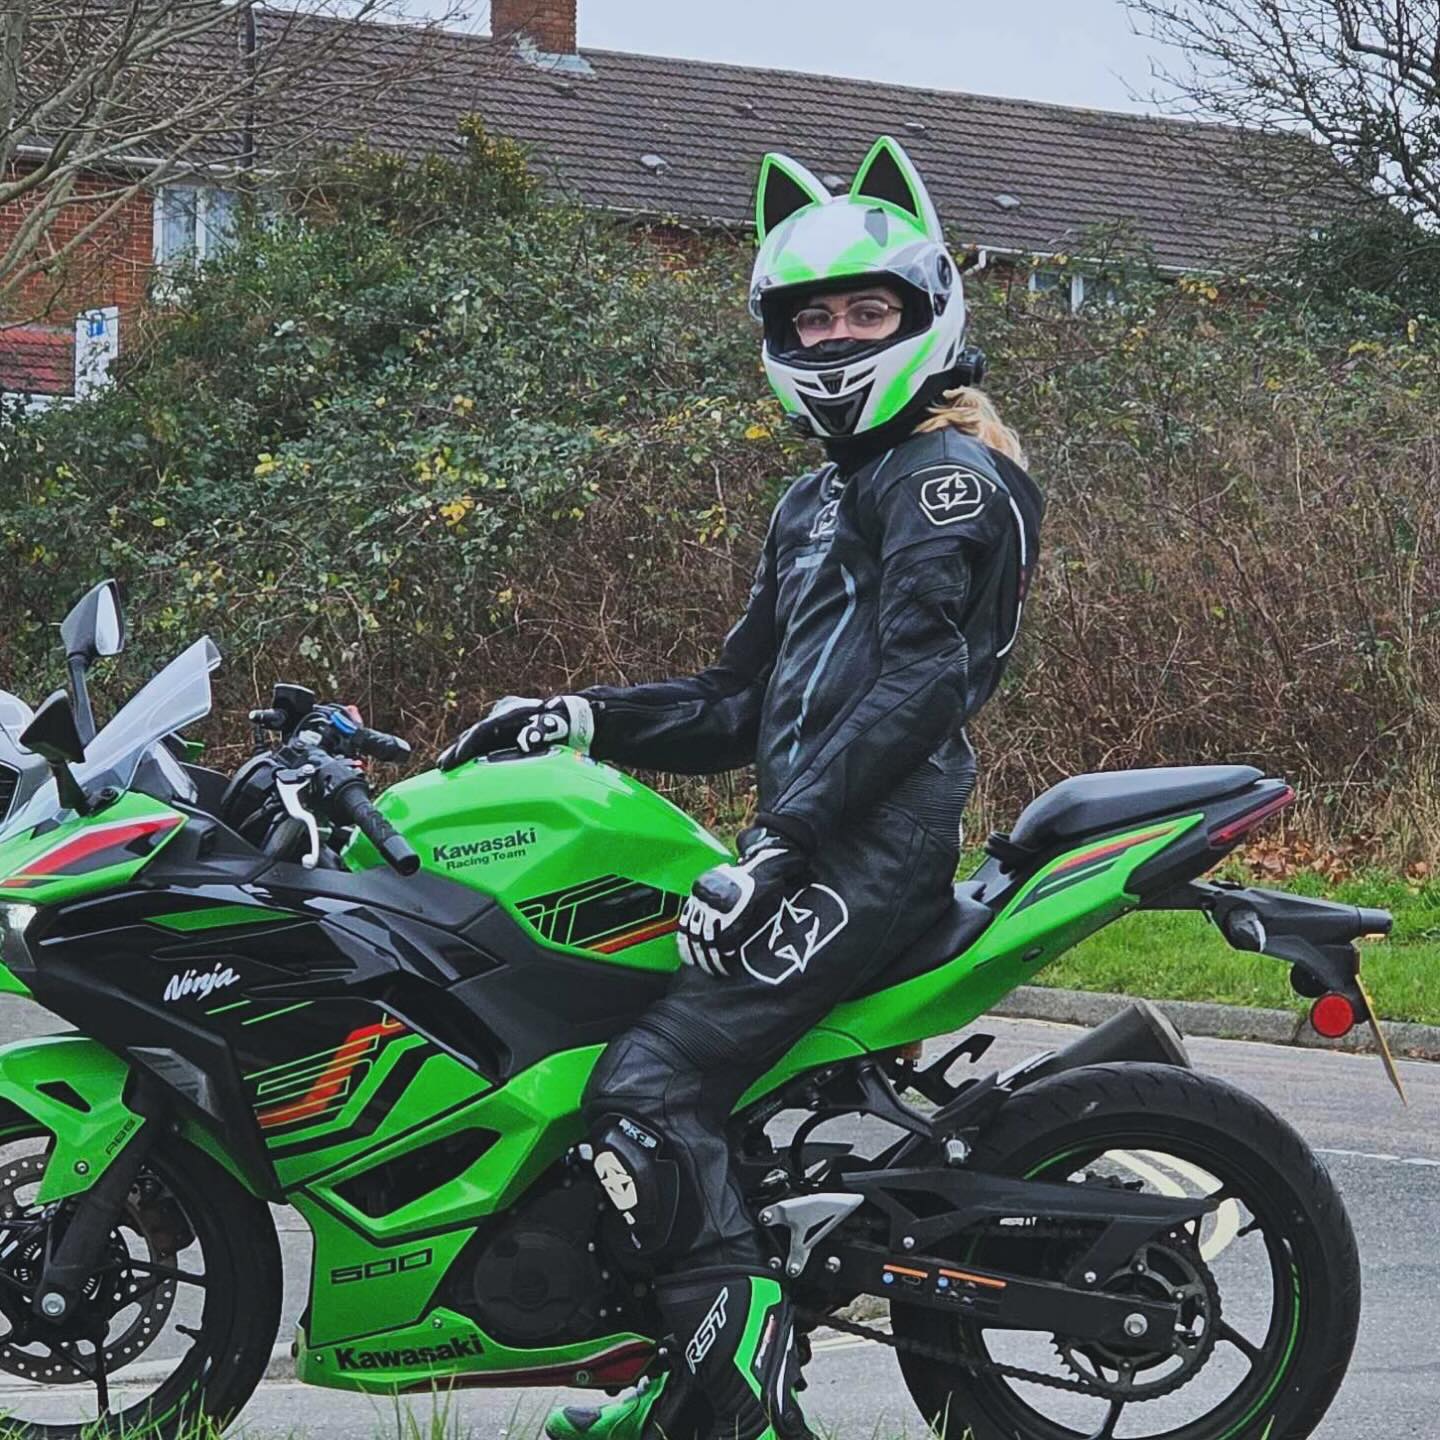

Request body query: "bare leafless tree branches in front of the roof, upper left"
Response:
[0, 0, 489, 318]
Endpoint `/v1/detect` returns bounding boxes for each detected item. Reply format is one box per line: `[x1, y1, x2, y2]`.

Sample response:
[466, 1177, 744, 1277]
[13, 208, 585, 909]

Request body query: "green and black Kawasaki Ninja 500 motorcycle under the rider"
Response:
[0, 585, 1390, 1440]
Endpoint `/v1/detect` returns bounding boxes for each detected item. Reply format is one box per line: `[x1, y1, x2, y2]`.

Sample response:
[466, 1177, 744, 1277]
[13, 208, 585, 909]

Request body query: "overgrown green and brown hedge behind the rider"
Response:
[0, 127, 1440, 852]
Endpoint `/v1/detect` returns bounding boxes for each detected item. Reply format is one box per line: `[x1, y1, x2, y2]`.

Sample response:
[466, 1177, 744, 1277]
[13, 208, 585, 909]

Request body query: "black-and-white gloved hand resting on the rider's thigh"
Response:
[678, 829, 809, 975]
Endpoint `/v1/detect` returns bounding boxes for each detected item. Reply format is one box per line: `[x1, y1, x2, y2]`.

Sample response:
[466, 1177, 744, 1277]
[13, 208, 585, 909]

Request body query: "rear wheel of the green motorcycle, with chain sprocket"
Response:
[893, 1064, 1359, 1440]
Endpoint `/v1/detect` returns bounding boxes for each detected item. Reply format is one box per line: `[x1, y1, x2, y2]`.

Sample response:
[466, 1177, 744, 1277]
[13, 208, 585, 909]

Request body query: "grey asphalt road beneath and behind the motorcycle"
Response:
[0, 1021, 1440, 1440]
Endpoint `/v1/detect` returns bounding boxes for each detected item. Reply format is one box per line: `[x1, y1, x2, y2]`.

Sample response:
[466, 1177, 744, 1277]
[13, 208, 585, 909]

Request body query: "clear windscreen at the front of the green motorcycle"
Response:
[0, 636, 220, 837]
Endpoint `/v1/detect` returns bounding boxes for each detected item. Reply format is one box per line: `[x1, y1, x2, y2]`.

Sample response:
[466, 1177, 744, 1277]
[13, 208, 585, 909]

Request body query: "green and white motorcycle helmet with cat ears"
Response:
[750, 135, 978, 436]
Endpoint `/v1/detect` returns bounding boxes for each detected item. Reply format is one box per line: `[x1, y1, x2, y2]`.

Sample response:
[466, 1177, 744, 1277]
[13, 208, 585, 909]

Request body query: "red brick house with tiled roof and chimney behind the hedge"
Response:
[0, 0, 1319, 395]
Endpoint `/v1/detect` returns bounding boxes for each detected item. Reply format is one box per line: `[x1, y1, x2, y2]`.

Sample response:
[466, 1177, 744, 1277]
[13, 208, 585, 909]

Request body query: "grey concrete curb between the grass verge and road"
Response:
[989, 985, 1440, 1060]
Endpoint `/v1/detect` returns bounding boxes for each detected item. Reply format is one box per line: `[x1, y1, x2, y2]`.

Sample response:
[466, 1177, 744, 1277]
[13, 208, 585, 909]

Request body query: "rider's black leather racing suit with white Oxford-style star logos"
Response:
[585, 429, 1043, 1273]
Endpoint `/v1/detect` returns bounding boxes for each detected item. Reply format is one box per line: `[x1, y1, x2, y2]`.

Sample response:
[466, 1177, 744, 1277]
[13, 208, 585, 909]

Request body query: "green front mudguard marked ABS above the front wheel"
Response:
[0, 1035, 140, 1205]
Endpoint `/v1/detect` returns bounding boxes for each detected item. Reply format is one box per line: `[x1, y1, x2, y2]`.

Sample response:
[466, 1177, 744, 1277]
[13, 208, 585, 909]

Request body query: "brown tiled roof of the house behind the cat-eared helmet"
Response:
[259, 22, 1324, 268]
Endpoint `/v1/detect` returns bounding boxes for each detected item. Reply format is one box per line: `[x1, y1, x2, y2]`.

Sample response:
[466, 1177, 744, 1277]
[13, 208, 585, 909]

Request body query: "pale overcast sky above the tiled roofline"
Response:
[413, 0, 1192, 109]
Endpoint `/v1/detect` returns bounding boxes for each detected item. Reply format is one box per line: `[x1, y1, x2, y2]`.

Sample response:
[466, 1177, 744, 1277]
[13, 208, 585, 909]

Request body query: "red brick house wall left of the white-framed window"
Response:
[0, 163, 154, 324]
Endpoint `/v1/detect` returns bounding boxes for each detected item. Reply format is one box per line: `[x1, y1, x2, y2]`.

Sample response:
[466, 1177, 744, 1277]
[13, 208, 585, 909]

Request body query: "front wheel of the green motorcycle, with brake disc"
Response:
[0, 1120, 281, 1440]
